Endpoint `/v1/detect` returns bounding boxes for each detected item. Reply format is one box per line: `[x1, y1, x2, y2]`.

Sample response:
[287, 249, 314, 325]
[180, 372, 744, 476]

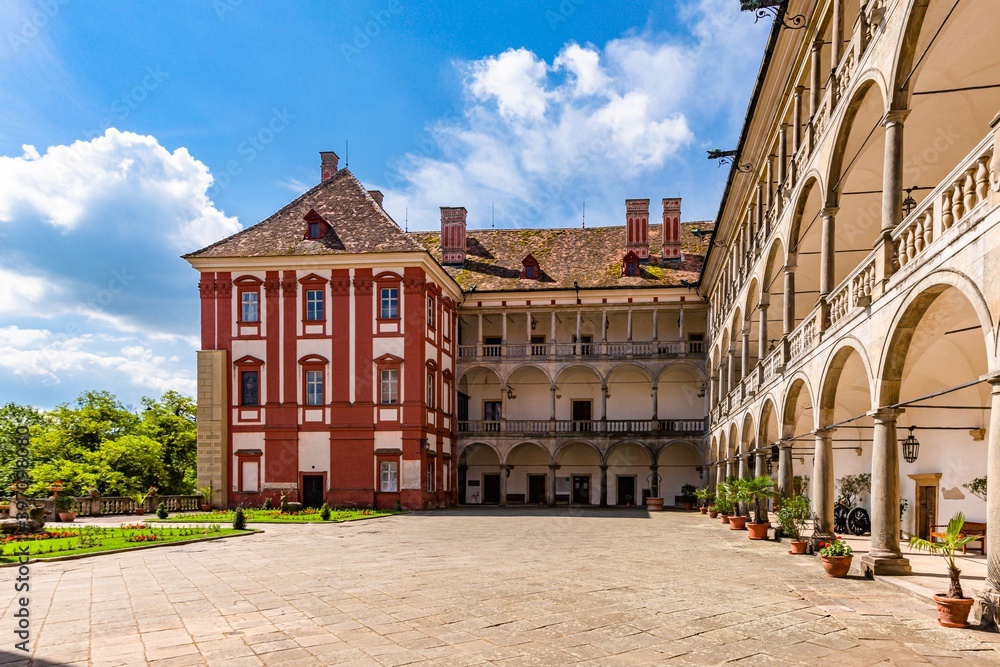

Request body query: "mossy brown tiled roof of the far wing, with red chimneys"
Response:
[410, 222, 713, 292]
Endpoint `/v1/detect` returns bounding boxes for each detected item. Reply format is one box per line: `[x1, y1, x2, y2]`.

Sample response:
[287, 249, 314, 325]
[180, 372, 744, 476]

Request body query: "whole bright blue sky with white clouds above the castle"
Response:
[0, 0, 768, 407]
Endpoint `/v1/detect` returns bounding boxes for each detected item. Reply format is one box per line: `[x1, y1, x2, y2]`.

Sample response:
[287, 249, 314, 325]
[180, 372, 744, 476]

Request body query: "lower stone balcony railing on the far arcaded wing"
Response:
[458, 417, 708, 435]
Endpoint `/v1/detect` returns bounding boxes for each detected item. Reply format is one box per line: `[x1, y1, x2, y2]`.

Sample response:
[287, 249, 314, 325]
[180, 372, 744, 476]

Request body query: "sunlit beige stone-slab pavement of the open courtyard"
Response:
[0, 508, 1000, 667]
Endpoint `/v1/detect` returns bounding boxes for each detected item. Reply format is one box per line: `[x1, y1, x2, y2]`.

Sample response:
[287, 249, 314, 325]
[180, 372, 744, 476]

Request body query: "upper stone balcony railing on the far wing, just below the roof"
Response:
[458, 340, 705, 361]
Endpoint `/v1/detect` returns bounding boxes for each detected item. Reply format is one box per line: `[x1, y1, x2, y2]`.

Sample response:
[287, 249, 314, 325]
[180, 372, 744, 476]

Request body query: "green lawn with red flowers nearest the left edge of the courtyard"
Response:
[0, 523, 250, 563]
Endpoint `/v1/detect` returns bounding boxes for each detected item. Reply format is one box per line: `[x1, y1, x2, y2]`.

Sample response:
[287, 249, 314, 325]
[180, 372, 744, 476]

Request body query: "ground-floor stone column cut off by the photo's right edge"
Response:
[973, 373, 1000, 632]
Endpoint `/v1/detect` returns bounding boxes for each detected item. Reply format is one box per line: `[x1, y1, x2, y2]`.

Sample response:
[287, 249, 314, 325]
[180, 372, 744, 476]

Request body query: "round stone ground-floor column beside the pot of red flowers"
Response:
[861, 408, 910, 575]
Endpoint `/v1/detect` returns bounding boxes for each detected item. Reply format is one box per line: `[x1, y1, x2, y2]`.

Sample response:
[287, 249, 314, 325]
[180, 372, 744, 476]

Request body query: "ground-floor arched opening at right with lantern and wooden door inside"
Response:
[873, 284, 992, 535]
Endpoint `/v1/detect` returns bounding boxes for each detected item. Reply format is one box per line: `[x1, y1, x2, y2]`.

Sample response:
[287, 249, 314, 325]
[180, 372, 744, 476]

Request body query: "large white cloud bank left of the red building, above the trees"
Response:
[0, 128, 241, 404]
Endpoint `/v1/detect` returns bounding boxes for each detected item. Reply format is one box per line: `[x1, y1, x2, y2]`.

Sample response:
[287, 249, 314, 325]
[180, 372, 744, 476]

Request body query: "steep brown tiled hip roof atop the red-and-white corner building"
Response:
[185, 169, 423, 257]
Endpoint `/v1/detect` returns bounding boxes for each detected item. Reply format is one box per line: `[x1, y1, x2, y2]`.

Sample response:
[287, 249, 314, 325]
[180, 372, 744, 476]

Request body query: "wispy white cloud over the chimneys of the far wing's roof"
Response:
[373, 0, 767, 229]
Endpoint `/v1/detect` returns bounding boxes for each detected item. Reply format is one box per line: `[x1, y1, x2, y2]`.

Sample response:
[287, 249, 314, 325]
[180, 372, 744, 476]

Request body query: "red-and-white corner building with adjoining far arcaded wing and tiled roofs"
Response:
[185, 153, 712, 509]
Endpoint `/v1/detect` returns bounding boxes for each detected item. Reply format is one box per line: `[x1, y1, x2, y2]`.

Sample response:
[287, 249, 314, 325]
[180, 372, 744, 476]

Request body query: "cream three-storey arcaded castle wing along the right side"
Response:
[700, 0, 1000, 609]
